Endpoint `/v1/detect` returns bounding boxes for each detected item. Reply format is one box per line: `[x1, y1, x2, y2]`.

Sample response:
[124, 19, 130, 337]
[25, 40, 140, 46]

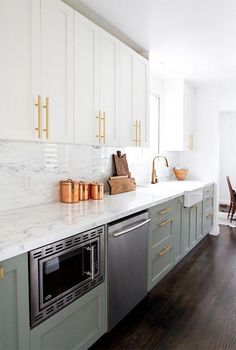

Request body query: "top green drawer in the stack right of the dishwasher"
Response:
[149, 198, 178, 222]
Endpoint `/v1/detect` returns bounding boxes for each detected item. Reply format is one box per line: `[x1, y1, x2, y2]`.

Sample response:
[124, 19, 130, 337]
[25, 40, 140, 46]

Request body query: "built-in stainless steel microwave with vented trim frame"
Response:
[29, 226, 104, 327]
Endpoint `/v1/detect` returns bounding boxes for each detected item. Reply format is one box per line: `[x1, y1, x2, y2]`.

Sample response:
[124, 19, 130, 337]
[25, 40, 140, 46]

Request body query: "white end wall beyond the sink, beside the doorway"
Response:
[179, 86, 219, 233]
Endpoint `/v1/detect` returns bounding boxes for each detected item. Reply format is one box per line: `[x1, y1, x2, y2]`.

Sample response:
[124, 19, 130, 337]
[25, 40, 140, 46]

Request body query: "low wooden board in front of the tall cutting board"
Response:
[107, 175, 136, 194]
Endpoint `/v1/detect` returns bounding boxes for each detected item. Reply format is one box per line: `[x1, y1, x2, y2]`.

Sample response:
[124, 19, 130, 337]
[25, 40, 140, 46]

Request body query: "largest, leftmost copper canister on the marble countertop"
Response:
[60, 179, 79, 203]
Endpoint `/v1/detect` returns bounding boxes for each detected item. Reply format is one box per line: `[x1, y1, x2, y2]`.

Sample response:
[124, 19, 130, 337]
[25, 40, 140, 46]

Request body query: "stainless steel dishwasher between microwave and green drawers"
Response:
[108, 212, 150, 330]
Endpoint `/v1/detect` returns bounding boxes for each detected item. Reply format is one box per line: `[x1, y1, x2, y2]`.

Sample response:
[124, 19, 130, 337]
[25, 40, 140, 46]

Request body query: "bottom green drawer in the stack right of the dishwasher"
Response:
[148, 237, 173, 290]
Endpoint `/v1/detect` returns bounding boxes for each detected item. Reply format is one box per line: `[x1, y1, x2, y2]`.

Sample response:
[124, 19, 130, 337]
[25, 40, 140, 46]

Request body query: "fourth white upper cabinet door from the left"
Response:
[100, 30, 119, 146]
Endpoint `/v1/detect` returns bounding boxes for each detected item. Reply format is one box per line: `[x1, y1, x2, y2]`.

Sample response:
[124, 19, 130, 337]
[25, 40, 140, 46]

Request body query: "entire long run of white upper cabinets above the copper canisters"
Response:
[0, 0, 149, 146]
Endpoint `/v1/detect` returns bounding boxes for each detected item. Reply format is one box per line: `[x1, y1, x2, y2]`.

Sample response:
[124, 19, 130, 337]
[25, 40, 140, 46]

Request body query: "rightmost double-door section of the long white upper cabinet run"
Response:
[119, 44, 149, 147]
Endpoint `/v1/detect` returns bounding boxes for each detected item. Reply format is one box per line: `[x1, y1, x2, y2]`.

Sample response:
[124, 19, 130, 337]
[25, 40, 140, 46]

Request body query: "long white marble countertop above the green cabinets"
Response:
[0, 181, 211, 261]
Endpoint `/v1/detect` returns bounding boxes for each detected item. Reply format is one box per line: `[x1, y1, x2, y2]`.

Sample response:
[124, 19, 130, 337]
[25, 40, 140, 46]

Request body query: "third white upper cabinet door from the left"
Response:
[74, 13, 101, 144]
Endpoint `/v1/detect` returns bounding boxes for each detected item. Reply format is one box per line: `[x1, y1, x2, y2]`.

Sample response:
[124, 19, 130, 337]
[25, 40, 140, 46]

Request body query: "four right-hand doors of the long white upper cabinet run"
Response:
[75, 13, 149, 146]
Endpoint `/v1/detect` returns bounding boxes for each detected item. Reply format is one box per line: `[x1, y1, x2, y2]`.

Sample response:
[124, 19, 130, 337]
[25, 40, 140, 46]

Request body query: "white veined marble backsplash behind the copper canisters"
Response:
[0, 141, 178, 210]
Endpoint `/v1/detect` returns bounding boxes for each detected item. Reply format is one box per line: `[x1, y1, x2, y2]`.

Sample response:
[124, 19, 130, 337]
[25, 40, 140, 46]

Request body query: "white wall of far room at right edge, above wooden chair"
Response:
[219, 112, 236, 204]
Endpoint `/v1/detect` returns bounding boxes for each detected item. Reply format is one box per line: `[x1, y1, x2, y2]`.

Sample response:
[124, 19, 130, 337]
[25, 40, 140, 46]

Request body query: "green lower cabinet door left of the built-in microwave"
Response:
[0, 254, 29, 350]
